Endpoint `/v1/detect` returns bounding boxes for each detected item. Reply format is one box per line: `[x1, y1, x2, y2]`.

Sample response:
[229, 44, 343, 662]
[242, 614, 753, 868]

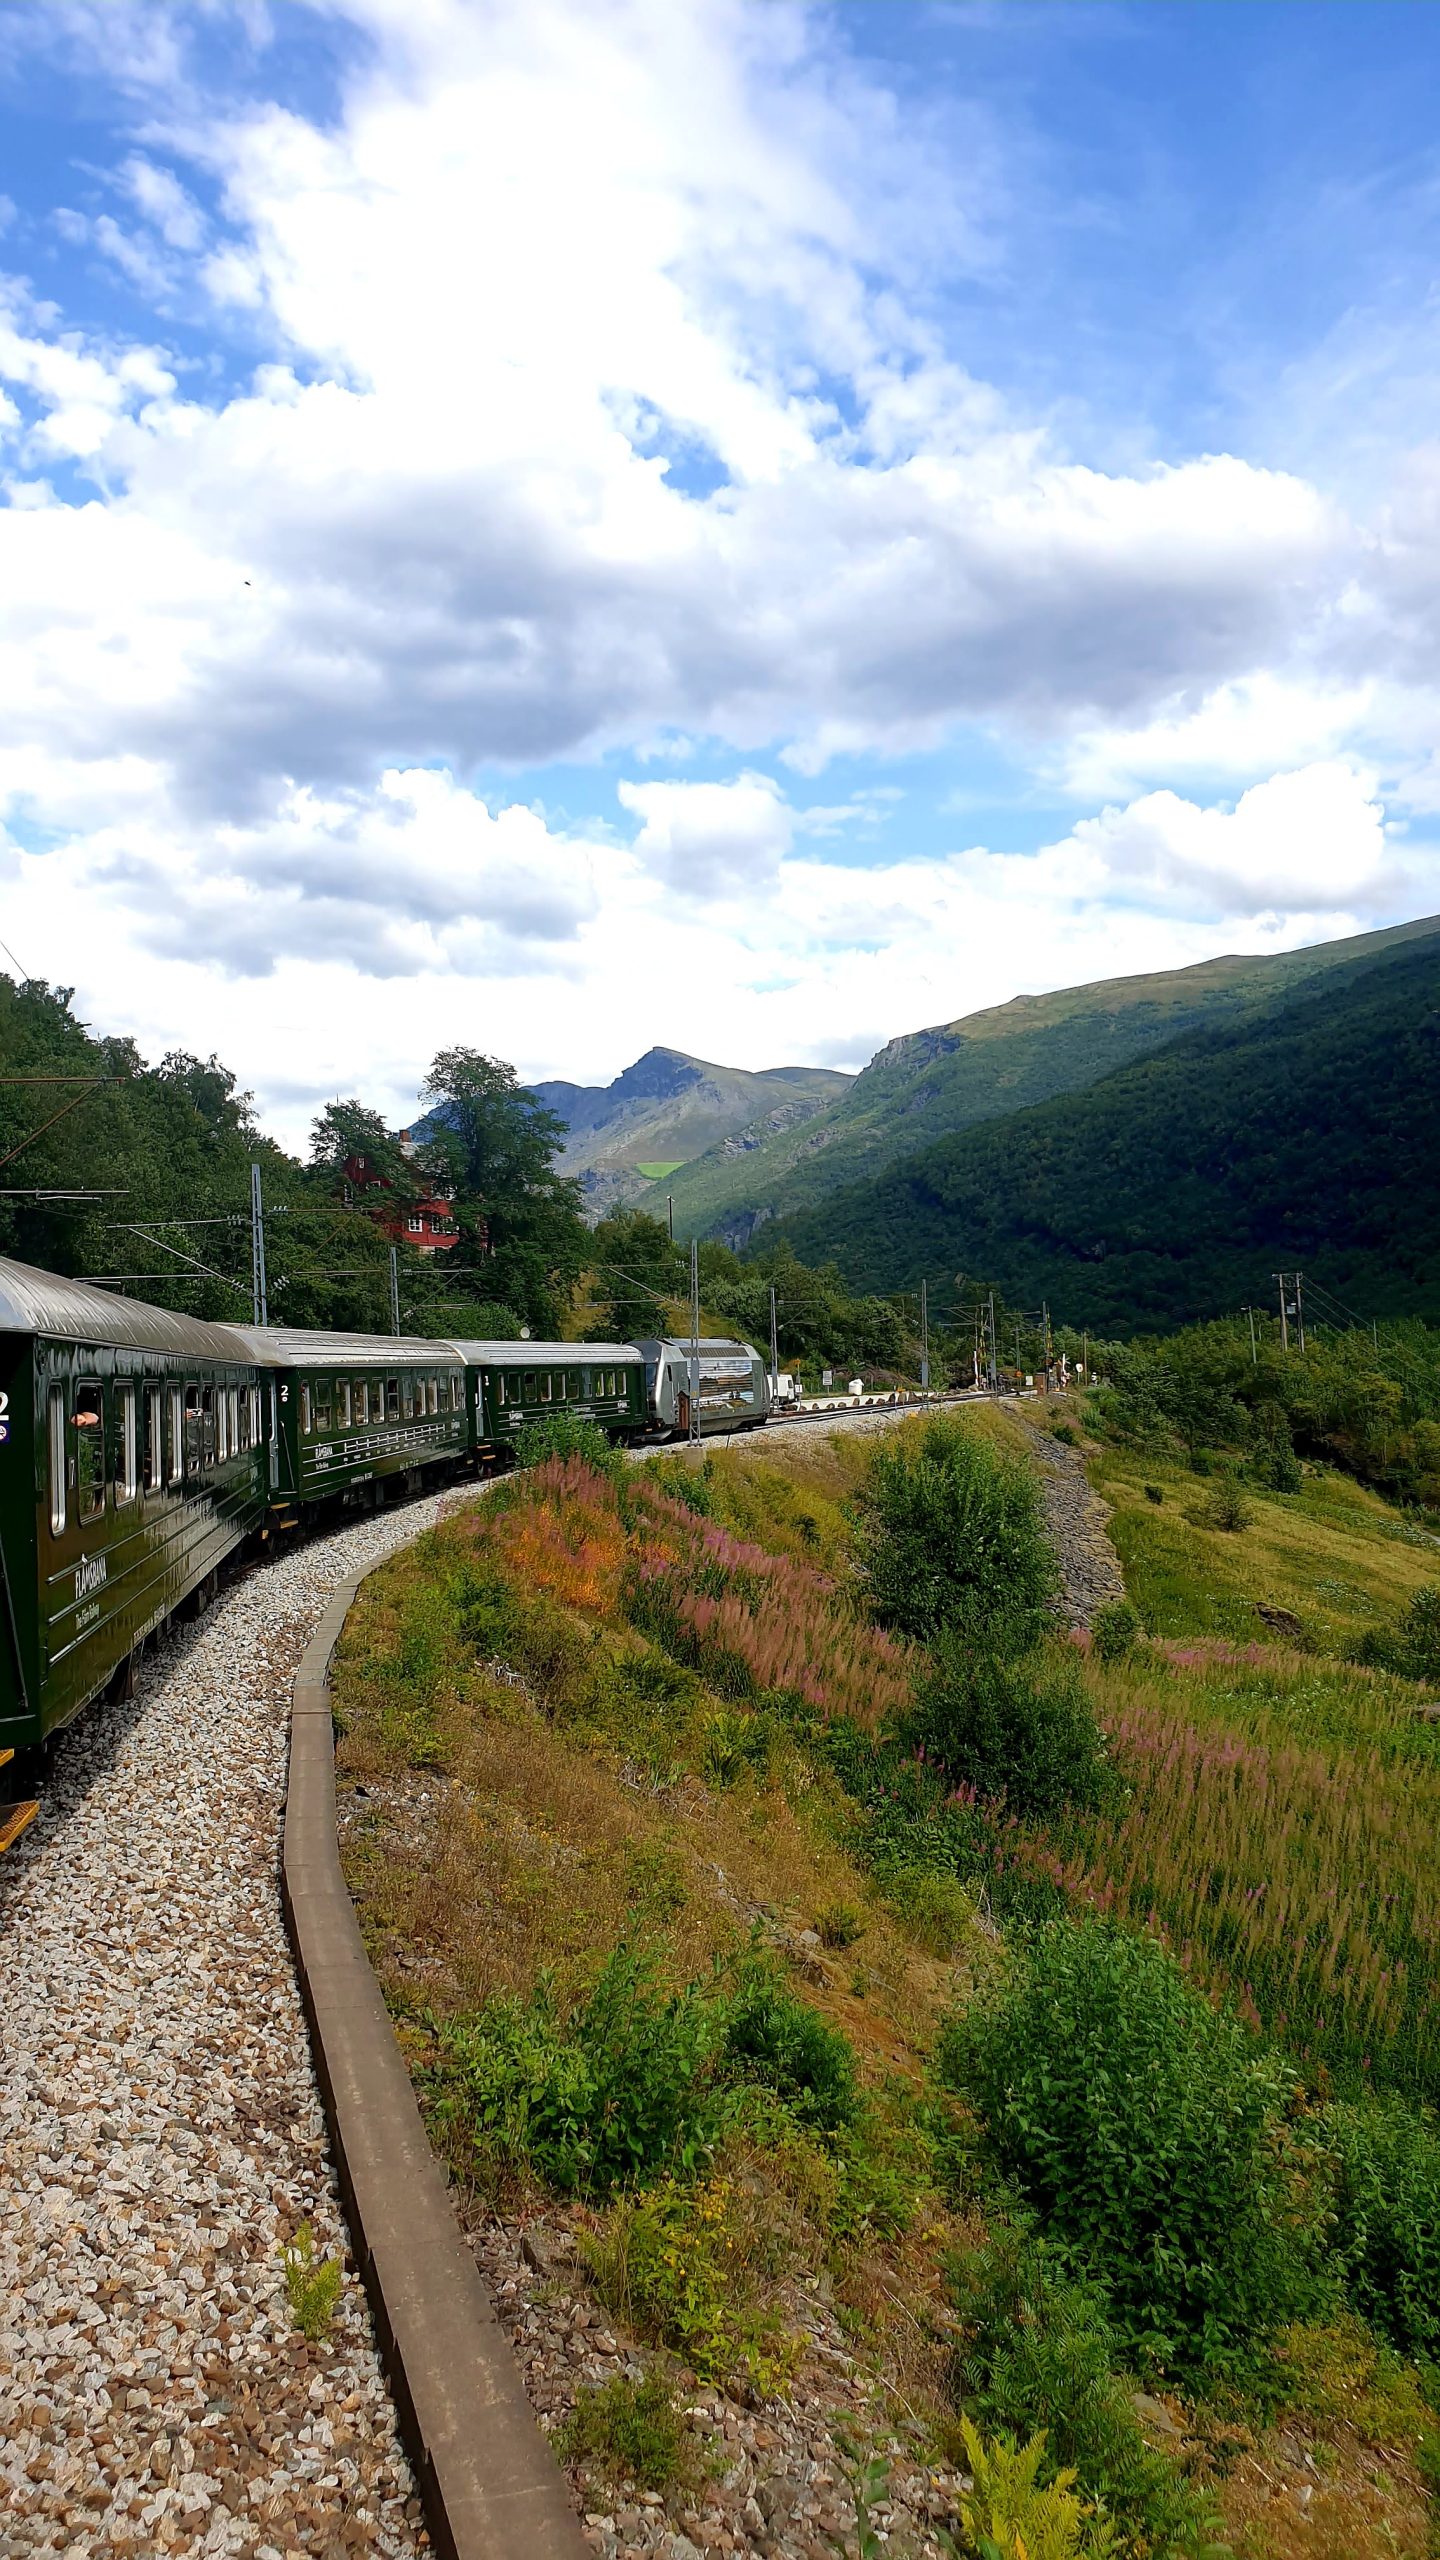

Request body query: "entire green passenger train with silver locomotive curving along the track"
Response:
[0, 1260, 769, 1848]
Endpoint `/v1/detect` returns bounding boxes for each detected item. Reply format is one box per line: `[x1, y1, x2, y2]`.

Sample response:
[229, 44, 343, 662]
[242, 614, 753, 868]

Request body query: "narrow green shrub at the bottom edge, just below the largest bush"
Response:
[951, 2225, 1215, 2555]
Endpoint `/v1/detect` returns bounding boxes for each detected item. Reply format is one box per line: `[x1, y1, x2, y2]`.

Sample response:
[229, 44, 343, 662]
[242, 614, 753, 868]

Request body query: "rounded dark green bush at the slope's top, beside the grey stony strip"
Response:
[858, 1421, 1056, 1649]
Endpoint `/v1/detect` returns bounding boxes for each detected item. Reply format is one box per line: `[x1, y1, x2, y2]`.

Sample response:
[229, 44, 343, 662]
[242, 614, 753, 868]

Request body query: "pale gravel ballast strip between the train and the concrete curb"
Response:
[0, 1498, 443, 2560]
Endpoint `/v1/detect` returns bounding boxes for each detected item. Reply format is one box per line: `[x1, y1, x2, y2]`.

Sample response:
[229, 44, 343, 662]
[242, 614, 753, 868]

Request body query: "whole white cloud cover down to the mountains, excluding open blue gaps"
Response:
[0, 0, 1440, 1141]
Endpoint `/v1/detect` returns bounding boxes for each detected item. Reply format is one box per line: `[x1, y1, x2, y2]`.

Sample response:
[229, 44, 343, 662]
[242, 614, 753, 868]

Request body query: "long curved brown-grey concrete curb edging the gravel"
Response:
[282, 1567, 587, 2560]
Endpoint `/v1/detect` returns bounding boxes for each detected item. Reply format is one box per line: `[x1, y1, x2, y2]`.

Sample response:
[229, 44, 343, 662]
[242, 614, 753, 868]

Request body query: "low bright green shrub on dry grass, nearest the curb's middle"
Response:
[422, 1943, 723, 2194]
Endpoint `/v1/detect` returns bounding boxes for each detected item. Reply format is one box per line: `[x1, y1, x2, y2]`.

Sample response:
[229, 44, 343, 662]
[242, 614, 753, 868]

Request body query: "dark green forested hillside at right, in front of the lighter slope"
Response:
[766, 932, 1440, 1331]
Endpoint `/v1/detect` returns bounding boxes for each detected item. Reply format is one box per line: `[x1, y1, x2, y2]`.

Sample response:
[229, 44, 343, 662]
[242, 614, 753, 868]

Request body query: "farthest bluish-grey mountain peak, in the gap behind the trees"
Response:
[530, 1047, 853, 1216]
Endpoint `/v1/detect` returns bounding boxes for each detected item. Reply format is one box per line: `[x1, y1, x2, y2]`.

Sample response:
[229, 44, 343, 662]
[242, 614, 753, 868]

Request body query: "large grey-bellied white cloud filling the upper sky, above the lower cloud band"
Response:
[0, 0, 1353, 814]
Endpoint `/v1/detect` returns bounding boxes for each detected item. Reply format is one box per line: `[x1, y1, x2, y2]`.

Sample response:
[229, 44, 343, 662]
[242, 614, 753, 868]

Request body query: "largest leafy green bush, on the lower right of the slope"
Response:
[940, 1917, 1304, 2376]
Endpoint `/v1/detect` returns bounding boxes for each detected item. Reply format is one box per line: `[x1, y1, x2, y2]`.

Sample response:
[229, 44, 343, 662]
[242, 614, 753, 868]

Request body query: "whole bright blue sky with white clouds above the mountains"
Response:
[0, 0, 1440, 1134]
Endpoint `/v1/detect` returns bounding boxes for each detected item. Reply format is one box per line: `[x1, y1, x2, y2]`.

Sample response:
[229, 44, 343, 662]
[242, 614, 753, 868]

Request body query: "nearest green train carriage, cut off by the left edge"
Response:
[0, 1260, 272, 1846]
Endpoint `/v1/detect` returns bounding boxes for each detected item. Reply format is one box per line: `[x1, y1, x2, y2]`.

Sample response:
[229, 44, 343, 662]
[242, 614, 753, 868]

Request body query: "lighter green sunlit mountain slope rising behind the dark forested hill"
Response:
[666, 919, 1435, 1234]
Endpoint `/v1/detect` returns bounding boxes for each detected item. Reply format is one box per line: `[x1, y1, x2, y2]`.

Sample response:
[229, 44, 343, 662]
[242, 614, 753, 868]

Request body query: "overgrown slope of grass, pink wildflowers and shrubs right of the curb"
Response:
[327, 1416, 1440, 2560]
